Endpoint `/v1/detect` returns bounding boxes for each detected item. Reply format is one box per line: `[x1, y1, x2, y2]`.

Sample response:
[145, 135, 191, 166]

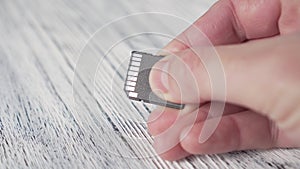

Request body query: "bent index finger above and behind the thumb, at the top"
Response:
[163, 0, 282, 53]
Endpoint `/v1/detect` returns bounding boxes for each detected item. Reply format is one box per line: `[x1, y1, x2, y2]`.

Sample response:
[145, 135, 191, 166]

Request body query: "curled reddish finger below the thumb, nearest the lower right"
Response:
[180, 111, 277, 154]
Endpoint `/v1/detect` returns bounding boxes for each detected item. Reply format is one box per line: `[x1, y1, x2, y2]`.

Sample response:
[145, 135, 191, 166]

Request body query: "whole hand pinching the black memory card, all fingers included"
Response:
[148, 0, 300, 161]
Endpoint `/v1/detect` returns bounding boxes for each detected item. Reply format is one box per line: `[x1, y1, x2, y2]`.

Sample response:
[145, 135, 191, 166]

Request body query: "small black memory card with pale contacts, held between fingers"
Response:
[124, 51, 184, 109]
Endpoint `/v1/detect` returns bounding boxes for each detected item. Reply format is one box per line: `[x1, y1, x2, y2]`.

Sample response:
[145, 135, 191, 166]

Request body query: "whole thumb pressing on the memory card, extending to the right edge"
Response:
[149, 34, 300, 136]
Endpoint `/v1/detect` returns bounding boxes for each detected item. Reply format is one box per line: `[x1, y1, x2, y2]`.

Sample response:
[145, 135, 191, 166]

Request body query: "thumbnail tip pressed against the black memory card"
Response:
[149, 60, 170, 94]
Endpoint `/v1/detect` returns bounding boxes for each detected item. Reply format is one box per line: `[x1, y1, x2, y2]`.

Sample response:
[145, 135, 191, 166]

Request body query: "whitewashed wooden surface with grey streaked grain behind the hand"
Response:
[0, 0, 300, 168]
